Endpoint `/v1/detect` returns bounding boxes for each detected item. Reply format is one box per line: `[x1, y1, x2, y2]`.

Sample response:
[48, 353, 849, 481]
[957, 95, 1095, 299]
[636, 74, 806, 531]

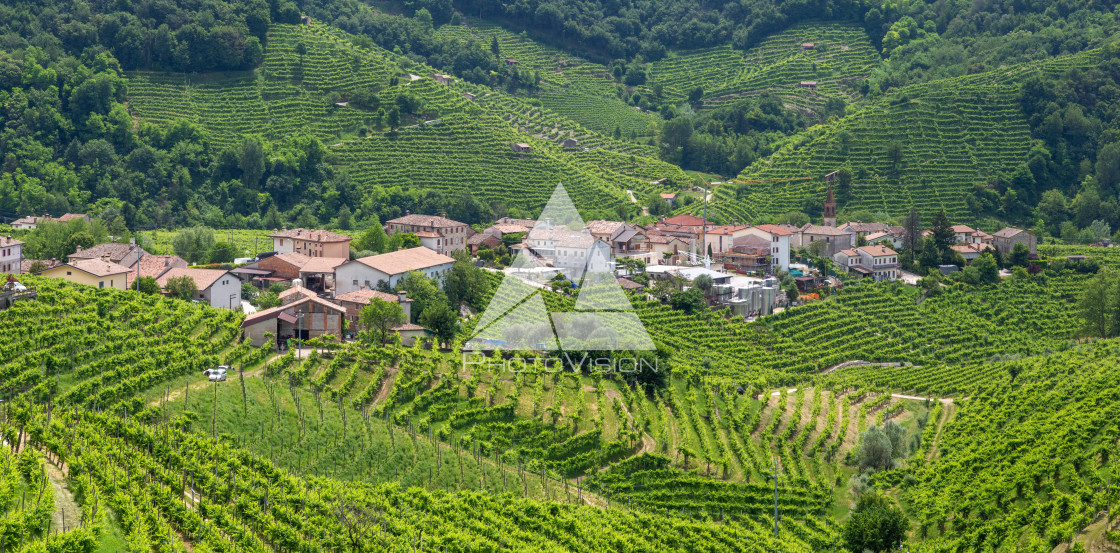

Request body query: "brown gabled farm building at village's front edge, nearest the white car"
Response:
[241, 296, 346, 346]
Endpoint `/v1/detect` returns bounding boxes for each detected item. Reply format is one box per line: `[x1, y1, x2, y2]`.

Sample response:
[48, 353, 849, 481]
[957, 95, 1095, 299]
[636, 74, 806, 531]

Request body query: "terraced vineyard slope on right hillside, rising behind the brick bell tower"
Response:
[690, 45, 1099, 221]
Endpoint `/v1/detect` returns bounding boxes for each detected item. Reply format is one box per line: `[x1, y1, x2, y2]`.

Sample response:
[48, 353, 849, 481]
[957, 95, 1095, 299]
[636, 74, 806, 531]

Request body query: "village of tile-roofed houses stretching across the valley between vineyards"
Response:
[0, 183, 1037, 345]
